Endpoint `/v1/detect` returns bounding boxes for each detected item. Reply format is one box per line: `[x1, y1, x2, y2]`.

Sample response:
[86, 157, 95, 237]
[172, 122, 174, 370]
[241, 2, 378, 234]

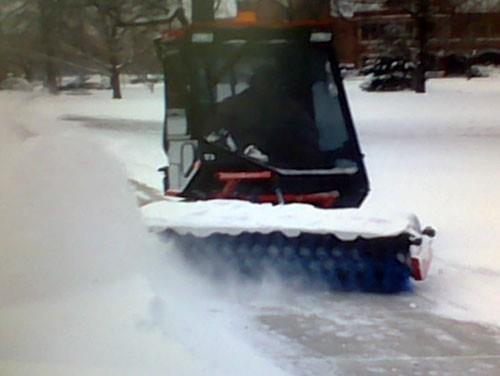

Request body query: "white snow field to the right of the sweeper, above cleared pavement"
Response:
[347, 77, 500, 326]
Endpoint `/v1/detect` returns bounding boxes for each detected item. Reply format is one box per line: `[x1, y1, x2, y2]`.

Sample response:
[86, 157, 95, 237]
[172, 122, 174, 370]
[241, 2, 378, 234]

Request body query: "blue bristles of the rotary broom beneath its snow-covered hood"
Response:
[164, 230, 412, 293]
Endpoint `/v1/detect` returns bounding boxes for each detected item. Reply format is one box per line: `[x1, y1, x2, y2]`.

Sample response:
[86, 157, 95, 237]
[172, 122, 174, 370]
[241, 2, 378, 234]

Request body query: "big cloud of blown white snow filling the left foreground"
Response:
[0, 96, 290, 376]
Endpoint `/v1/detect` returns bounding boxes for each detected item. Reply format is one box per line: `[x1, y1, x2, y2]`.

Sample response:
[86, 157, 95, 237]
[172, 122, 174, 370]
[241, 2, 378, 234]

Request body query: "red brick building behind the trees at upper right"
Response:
[334, 0, 500, 68]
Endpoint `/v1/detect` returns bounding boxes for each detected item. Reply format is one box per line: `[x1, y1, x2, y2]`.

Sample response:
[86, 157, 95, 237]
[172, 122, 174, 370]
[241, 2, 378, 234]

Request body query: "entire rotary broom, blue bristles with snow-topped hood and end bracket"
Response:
[146, 200, 435, 293]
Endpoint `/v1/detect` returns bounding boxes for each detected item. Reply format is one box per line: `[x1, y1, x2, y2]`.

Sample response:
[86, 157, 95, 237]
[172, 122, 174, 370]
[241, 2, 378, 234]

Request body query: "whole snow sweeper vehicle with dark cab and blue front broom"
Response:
[145, 2, 434, 292]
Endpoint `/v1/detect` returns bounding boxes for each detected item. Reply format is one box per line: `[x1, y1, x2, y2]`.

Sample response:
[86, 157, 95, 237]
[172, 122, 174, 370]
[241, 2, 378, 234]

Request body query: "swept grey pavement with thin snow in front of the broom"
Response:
[250, 294, 500, 375]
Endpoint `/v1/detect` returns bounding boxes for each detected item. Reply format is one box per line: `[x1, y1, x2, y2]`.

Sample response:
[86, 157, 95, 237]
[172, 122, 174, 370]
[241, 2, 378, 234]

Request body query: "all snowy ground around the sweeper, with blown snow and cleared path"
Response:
[0, 77, 500, 375]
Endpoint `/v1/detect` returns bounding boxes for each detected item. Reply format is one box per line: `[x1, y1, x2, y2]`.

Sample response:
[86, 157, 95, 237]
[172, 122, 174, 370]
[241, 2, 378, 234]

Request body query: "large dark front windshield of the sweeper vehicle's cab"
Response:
[193, 40, 349, 168]
